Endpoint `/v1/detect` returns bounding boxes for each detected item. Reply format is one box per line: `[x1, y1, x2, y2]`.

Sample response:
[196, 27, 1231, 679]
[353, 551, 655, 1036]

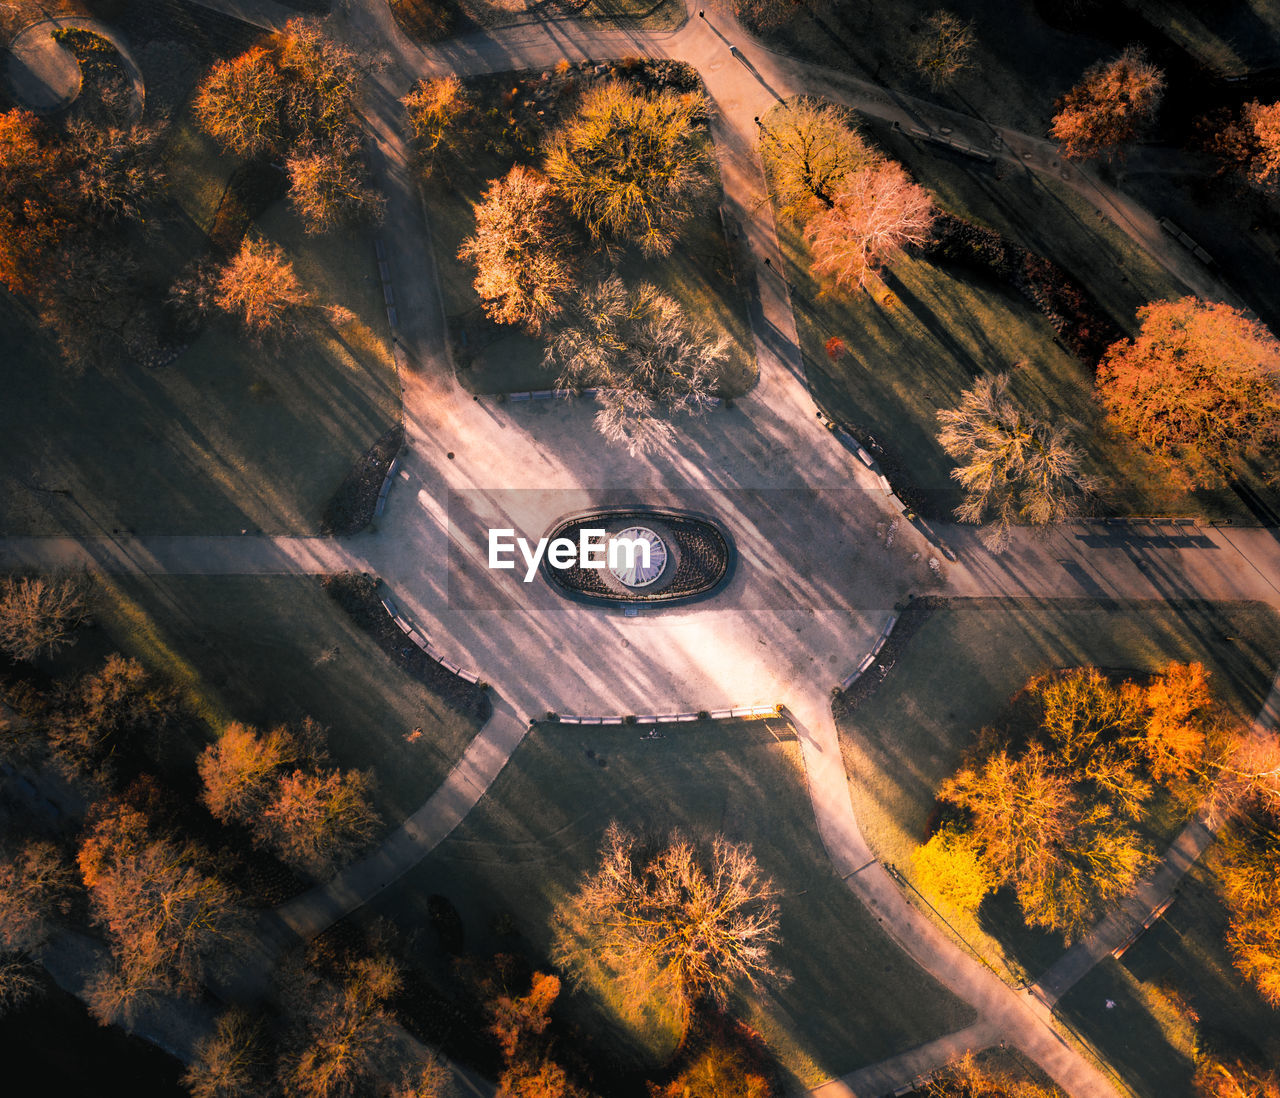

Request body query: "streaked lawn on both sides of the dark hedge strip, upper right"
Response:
[780, 106, 1259, 518]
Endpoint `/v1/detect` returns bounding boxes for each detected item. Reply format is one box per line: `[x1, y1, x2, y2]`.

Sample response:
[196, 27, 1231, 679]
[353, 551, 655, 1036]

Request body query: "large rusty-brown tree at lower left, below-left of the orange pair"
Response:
[78, 801, 244, 1021]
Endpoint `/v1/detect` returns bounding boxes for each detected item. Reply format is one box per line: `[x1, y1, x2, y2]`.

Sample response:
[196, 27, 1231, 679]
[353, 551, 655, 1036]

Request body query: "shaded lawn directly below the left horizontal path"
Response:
[67, 576, 477, 823]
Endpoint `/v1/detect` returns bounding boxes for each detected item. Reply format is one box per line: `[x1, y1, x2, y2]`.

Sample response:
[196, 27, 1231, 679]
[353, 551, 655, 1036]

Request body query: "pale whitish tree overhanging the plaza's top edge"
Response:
[544, 275, 728, 454]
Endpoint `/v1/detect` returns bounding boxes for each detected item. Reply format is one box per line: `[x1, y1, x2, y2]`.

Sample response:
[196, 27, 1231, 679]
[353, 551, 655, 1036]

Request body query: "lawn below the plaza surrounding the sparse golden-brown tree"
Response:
[371, 720, 969, 1086]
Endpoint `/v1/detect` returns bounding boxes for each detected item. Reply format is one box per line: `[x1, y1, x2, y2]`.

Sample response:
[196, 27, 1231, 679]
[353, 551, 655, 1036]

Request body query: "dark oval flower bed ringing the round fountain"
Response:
[543, 511, 733, 603]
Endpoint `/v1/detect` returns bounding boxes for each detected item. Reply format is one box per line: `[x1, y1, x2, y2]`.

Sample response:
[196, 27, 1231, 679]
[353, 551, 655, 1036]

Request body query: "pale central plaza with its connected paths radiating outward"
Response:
[10, 0, 1280, 1098]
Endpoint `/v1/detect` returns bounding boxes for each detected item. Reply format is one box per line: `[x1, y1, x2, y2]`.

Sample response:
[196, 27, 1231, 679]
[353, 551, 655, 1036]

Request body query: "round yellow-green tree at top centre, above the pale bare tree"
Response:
[545, 81, 712, 256]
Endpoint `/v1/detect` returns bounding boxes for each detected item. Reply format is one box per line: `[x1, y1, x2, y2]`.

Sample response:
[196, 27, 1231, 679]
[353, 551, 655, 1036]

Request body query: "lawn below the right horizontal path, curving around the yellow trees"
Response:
[840, 599, 1280, 978]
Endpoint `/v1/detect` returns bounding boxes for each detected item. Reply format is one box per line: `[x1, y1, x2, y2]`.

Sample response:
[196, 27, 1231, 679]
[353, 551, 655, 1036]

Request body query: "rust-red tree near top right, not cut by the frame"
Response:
[1050, 49, 1165, 160]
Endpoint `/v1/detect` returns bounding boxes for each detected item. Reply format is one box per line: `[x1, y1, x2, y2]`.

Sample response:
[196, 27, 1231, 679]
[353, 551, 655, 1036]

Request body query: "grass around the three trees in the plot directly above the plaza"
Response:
[426, 69, 756, 397]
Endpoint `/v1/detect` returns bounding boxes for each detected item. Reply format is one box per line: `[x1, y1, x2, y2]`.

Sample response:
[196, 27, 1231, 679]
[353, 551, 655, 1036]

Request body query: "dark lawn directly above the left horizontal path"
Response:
[0, 114, 399, 534]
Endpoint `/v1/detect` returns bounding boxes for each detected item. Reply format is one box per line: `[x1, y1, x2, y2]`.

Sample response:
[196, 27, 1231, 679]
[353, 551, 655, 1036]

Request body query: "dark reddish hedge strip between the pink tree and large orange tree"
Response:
[924, 212, 1124, 366]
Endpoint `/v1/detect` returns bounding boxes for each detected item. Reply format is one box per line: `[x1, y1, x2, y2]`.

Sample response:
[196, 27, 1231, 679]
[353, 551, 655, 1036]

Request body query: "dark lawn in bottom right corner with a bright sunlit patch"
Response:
[1059, 865, 1280, 1098]
